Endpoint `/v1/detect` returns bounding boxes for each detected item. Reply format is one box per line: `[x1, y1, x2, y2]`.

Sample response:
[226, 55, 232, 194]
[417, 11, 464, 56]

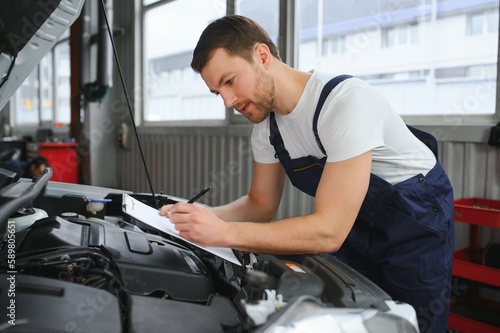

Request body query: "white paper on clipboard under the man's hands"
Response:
[122, 193, 241, 265]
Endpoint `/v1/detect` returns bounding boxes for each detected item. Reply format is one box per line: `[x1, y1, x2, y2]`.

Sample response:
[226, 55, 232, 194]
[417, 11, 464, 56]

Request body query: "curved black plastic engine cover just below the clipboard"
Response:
[11, 217, 213, 302]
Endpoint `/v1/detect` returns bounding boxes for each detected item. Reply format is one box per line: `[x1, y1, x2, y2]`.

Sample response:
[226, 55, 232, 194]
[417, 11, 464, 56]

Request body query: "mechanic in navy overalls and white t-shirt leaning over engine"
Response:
[160, 15, 454, 333]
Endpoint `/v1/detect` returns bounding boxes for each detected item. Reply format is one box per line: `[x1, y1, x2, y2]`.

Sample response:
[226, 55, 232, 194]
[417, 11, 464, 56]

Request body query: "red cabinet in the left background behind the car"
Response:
[38, 142, 80, 184]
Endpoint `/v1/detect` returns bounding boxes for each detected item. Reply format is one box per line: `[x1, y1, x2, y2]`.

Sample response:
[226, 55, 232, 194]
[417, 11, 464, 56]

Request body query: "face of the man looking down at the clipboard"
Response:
[201, 48, 275, 124]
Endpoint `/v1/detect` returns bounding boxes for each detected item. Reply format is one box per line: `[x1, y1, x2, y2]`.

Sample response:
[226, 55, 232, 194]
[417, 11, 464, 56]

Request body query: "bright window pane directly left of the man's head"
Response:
[143, 0, 226, 122]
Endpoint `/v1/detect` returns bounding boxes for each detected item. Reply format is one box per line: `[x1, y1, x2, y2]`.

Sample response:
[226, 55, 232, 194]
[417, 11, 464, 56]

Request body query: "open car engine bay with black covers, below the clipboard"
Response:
[0, 169, 417, 332]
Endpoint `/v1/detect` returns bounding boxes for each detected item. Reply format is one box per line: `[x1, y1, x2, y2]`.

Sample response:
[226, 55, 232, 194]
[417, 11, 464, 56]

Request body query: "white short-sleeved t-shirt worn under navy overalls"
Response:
[252, 72, 436, 184]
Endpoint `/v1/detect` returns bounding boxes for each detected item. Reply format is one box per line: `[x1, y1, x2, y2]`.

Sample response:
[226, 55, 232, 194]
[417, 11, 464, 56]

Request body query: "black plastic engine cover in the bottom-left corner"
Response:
[0, 274, 122, 333]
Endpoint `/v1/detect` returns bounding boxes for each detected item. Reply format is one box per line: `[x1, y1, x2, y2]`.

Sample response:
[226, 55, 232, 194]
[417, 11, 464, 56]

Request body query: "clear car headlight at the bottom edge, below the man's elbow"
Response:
[259, 296, 418, 333]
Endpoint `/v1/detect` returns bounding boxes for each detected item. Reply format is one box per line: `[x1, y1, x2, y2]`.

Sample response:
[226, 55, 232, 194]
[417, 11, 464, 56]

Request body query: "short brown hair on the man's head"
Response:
[191, 15, 280, 73]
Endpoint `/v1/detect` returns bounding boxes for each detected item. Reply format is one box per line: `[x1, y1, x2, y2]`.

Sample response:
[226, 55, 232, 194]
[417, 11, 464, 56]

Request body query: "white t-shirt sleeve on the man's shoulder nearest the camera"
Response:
[318, 78, 391, 162]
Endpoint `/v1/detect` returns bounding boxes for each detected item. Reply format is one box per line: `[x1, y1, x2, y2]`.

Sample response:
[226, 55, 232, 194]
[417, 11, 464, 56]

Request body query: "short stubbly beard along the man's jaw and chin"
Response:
[245, 67, 276, 124]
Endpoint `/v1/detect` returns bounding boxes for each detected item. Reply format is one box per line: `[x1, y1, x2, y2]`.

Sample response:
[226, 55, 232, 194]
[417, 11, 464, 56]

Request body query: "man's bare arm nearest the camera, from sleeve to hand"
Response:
[170, 151, 372, 254]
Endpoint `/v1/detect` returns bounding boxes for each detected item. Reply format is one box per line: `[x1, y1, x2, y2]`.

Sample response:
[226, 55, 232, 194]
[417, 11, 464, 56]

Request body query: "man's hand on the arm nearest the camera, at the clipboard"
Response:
[160, 202, 228, 246]
